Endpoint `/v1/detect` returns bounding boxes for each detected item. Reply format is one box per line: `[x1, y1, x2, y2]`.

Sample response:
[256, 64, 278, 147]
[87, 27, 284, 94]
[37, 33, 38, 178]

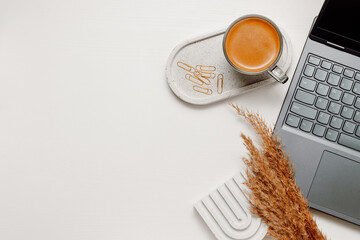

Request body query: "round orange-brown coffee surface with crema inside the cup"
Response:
[225, 17, 281, 72]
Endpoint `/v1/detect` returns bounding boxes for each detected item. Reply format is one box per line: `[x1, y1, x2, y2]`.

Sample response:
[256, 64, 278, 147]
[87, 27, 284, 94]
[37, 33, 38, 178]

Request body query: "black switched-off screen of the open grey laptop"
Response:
[310, 0, 360, 53]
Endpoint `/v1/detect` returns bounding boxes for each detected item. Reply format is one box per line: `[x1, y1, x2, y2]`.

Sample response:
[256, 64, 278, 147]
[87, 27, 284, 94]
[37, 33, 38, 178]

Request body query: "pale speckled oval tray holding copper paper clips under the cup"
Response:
[166, 28, 292, 105]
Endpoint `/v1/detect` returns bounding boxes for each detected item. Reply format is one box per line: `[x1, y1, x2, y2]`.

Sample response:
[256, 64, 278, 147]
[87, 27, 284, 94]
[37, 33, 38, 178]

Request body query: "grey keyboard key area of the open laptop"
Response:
[285, 54, 360, 151]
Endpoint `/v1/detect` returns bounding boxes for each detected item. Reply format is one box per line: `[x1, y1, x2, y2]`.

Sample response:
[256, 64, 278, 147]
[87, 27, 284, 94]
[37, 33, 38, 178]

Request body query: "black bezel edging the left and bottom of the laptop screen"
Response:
[309, 0, 360, 56]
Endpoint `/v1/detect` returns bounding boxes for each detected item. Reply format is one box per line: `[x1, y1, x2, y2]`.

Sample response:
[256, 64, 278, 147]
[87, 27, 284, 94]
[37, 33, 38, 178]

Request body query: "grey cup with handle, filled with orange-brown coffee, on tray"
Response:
[223, 15, 288, 83]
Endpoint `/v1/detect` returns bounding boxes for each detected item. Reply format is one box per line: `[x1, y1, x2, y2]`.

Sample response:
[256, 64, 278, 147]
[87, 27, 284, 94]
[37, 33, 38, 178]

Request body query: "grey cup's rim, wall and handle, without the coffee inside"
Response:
[223, 14, 289, 83]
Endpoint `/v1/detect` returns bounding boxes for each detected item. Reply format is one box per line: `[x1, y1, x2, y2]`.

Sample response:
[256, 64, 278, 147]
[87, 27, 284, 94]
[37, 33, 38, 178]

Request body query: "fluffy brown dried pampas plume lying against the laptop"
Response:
[232, 104, 326, 240]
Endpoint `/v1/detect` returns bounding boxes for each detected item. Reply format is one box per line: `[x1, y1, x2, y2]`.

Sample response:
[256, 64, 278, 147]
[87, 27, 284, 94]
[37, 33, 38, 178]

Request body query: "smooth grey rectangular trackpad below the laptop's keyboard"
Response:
[308, 151, 360, 219]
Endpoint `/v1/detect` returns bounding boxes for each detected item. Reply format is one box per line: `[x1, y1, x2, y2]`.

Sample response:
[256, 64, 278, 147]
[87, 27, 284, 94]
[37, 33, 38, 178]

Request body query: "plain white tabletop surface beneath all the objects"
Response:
[0, 0, 360, 240]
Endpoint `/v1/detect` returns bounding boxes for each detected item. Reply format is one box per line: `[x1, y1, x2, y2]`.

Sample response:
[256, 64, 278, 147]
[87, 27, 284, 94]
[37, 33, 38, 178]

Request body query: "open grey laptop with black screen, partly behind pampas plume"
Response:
[274, 0, 360, 225]
